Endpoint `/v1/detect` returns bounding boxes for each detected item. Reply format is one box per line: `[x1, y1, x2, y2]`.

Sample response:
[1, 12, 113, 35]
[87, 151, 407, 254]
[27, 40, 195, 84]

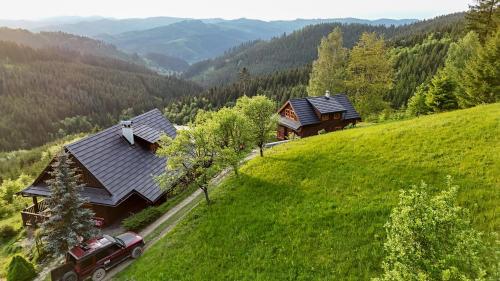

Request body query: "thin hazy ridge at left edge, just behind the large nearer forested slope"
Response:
[0, 27, 141, 63]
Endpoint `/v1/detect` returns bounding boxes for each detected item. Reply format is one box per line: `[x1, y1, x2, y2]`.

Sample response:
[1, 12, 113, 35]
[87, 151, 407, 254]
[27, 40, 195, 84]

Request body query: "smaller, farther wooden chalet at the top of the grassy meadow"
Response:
[277, 92, 361, 140]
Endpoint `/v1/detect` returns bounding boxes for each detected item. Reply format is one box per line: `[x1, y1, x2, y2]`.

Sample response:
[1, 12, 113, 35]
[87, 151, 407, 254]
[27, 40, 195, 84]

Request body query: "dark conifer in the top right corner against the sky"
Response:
[465, 0, 500, 42]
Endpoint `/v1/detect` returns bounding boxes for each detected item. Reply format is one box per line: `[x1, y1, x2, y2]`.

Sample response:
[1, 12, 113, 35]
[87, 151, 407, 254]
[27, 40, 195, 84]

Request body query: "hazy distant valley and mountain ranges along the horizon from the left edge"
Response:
[0, 17, 417, 70]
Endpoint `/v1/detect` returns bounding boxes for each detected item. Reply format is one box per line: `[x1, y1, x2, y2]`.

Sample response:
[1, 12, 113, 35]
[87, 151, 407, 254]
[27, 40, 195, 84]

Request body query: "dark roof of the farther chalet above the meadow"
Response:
[279, 94, 361, 130]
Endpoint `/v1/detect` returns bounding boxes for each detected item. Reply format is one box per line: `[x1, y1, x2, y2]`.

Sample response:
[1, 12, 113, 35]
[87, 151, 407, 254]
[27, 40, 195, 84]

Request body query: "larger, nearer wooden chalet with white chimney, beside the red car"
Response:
[19, 109, 176, 225]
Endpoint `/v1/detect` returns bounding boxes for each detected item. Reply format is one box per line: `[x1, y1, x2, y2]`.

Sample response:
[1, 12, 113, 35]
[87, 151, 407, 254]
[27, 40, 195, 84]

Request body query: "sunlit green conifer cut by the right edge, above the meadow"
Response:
[461, 28, 500, 106]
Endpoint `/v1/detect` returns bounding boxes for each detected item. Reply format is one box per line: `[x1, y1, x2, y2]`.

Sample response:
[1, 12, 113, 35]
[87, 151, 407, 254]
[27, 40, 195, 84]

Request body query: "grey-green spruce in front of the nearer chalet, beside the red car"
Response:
[42, 151, 98, 256]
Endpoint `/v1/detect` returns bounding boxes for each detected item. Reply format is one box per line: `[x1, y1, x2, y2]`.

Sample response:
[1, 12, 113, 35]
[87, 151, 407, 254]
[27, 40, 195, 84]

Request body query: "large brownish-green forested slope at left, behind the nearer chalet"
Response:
[0, 42, 200, 151]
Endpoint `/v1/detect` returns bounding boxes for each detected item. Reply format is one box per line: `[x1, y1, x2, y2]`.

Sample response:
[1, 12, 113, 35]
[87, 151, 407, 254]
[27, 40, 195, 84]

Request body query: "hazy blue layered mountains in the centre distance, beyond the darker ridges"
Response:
[94, 18, 415, 63]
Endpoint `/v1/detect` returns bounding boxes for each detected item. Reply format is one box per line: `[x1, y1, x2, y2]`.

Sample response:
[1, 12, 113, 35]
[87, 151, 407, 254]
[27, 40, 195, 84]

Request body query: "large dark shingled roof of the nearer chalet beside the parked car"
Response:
[22, 109, 176, 205]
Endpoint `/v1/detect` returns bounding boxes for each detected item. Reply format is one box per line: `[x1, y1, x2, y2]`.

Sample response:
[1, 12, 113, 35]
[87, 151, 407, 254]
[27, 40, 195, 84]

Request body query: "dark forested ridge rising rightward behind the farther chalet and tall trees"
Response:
[184, 13, 464, 86]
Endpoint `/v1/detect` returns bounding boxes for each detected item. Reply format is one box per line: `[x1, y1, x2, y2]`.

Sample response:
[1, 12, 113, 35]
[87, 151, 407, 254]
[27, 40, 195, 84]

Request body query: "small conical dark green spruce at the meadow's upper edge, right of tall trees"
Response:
[425, 70, 458, 112]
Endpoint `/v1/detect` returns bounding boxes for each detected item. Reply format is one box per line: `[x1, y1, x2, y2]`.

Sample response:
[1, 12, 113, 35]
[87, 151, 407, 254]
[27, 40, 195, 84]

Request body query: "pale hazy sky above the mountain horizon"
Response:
[0, 0, 472, 20]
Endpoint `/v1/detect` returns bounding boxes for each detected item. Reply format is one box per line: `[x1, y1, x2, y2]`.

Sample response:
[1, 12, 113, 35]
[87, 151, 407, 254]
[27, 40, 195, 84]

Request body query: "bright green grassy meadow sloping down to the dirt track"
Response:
[118, 104, 500, 280]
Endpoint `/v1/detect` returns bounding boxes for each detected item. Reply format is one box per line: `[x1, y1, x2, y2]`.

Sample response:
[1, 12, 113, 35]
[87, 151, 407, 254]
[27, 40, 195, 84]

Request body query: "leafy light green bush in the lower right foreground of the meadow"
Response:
[375, 177, 486, 281]
